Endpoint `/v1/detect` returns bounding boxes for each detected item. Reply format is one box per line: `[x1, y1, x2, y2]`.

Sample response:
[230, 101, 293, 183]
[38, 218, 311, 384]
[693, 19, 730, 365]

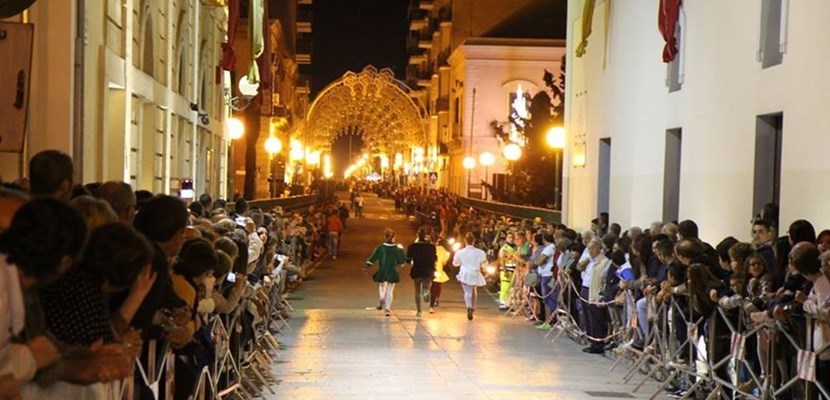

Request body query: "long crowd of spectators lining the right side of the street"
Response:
[393, 187, 830, 399]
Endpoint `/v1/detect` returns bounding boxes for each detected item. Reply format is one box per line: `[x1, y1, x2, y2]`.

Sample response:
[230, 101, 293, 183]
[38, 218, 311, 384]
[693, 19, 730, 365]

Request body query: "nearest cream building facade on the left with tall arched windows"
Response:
[0, 0, 227, 196]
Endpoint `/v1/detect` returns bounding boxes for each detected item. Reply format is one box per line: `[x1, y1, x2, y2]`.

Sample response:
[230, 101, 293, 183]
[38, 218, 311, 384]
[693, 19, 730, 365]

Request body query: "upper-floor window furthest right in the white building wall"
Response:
[757, 0, 790, 68]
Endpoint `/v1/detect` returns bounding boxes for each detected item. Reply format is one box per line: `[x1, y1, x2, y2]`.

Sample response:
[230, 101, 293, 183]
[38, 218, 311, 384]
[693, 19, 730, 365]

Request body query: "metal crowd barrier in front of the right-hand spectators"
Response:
[504, 276, 830, 400]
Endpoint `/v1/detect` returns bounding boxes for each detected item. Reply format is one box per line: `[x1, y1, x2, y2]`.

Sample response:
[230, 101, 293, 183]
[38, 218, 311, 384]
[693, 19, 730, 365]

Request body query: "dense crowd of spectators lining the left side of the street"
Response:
[0, 151, 344, 399]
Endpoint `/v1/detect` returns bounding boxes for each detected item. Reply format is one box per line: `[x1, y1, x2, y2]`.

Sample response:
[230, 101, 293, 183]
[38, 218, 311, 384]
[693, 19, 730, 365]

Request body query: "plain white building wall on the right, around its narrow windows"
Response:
[566, 0, 830, 242]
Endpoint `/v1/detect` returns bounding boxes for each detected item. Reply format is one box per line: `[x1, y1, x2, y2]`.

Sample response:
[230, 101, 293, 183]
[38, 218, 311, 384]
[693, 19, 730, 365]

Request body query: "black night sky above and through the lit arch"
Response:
[311, 0, 409, 177]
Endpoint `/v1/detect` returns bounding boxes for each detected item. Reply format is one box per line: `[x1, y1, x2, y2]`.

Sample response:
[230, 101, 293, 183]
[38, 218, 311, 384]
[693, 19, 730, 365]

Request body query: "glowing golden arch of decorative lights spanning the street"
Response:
[304, 65, 426, 154]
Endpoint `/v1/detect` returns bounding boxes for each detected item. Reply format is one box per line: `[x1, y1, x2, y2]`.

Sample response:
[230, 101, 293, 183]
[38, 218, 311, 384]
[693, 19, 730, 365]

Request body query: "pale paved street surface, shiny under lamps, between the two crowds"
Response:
[265, 194, 663, 400]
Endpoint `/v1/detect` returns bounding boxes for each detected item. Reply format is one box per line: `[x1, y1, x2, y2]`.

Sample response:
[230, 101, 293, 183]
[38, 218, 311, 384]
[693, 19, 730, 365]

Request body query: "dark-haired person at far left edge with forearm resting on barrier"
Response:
[0, 199, 132, 392]
